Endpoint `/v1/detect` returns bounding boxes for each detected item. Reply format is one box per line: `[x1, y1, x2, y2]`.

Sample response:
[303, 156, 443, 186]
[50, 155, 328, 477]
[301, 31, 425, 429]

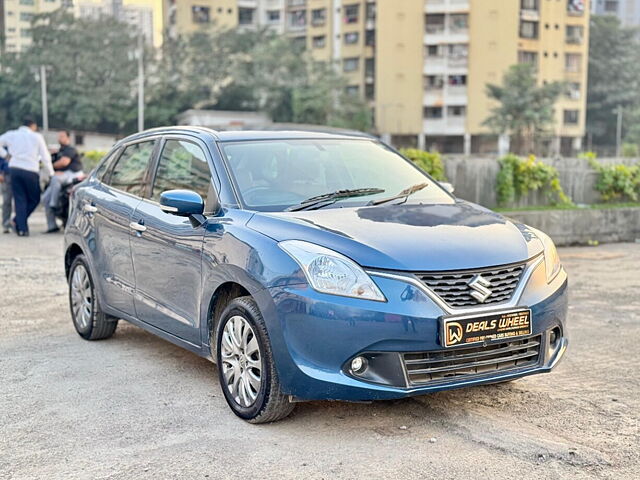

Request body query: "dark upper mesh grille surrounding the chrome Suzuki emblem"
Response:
[416, 263, 525, 308]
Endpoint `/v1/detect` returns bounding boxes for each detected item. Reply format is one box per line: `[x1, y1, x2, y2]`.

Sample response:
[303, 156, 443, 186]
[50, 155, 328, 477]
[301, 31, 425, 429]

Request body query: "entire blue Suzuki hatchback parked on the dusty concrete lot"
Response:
[65, 127, 567, 423]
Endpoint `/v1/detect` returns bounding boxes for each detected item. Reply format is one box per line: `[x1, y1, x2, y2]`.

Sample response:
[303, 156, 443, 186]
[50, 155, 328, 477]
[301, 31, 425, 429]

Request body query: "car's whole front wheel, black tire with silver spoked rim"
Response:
[216, 297, 295, 423]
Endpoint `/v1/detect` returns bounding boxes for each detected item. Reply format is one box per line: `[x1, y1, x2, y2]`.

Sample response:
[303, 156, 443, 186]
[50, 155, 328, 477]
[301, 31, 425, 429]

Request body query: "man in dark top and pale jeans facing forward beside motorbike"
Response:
[42, 130, 82, 233]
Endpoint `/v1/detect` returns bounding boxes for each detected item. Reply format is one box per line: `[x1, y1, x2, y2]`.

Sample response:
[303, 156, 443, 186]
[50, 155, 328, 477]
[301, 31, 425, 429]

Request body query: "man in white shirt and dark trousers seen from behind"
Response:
[0, 118, 53, 237]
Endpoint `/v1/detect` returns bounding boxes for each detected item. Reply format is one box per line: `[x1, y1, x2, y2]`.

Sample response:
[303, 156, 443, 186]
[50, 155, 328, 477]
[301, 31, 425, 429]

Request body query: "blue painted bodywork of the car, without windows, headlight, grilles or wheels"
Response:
[65, 127, 568, 401]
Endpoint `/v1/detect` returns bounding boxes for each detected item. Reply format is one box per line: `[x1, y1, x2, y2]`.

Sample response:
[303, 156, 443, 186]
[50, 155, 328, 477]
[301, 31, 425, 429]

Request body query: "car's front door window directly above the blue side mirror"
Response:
[151, 139, 211, 201]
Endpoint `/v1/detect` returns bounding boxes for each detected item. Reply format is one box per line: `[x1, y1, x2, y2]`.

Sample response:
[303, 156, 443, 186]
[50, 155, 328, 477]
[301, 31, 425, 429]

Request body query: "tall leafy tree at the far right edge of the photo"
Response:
[587, 15, 640, 146]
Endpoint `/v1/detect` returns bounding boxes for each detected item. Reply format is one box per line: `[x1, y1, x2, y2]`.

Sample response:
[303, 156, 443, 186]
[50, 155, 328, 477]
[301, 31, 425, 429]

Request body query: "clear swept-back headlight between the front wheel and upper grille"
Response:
[278, 240, 387, 302]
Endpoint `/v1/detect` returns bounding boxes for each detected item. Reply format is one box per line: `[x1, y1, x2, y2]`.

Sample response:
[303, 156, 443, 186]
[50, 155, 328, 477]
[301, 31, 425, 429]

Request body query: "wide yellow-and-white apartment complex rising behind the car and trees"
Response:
[166, 0, 592, 153]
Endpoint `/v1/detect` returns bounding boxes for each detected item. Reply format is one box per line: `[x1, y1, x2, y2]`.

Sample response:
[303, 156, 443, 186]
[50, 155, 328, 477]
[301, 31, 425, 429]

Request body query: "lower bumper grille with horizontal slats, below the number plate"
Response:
[403, 335, 541, 385]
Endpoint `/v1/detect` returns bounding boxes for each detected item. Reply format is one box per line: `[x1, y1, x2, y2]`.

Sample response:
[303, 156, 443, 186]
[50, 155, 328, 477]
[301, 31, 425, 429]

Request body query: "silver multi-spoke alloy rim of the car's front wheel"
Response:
[220, 315, 262, 408]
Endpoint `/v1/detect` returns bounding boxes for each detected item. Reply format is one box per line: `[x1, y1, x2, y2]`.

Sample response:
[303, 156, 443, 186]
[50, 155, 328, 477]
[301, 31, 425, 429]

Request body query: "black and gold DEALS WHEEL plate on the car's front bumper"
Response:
[441, 309, 531, 347]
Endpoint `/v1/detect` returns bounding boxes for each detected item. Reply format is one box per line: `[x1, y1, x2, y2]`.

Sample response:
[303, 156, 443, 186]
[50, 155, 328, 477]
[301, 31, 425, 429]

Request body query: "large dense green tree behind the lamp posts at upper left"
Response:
[0, 9, 137, 132]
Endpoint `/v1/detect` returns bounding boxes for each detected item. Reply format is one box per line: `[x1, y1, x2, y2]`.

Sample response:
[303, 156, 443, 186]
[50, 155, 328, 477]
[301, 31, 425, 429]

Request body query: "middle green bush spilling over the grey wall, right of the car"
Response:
[497, 154, 571, 206]
